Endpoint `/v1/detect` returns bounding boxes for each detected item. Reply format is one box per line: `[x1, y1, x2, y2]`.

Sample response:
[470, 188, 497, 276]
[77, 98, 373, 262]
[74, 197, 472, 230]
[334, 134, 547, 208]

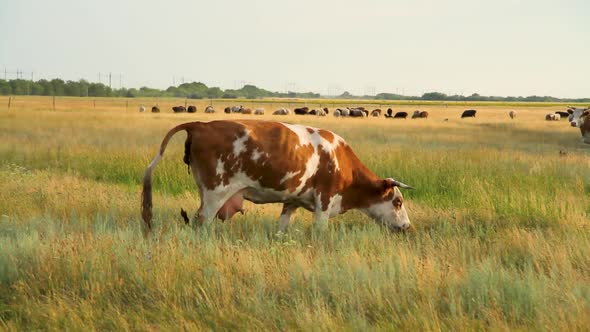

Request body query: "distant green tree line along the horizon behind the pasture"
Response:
[0, 79, 590, 103]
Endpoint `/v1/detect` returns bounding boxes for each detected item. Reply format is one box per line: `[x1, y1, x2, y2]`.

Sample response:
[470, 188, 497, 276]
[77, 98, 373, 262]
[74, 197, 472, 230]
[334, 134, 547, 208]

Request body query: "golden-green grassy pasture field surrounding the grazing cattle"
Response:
[0, 97, 590, 331]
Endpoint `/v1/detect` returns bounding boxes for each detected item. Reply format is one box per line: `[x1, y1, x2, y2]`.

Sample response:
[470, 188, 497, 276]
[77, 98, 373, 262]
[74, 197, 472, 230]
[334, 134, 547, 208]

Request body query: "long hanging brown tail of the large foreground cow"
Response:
[141, 122, 194, 235]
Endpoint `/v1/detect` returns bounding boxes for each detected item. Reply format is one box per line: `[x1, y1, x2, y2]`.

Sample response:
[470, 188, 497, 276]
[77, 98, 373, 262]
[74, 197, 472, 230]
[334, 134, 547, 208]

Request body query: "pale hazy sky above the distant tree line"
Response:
[0, 0, 590, 98]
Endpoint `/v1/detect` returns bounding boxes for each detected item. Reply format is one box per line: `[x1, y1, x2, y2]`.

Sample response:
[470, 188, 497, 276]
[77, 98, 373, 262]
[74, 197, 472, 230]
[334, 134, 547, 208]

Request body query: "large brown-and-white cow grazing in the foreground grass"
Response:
[141, 120, 413, 236]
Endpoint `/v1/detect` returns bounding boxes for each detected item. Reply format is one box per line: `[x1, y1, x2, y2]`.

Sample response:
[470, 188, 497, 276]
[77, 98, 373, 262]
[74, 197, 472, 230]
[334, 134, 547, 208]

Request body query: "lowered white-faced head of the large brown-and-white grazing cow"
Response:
[365, 178, 414, 231]
